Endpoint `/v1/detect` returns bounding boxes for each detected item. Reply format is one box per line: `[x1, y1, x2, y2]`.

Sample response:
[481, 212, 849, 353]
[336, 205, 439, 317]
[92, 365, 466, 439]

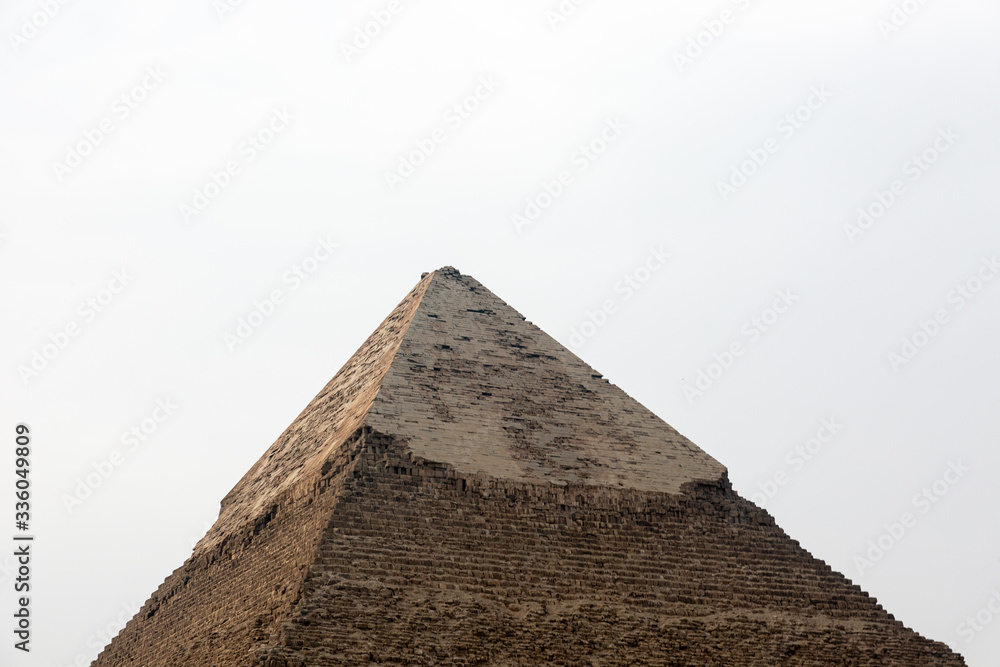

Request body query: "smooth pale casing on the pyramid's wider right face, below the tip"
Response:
[365, 266, 726, 493]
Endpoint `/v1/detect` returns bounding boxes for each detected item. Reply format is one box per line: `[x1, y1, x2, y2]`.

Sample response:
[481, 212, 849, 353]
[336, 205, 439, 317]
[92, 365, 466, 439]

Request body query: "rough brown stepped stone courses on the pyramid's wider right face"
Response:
[260, 434, 964, 667]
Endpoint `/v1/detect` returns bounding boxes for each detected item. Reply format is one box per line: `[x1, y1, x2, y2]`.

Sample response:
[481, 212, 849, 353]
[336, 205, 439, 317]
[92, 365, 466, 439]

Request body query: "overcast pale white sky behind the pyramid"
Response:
[0, 0, 1000, 667]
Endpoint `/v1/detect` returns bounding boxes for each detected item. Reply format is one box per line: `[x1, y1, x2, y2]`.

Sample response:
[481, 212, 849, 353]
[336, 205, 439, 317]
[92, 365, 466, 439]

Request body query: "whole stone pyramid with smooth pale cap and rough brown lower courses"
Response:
[93, 267, 965, 667]
